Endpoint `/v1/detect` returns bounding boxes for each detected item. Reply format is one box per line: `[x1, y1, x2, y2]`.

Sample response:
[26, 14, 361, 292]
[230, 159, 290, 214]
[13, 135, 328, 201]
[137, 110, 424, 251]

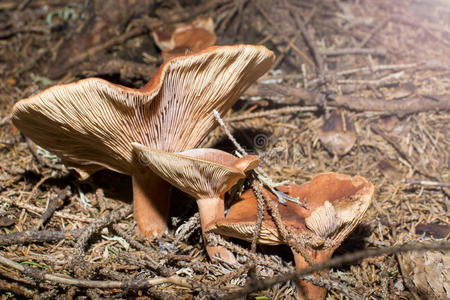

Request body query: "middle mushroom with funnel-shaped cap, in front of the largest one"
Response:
[133, 143, 258, 263]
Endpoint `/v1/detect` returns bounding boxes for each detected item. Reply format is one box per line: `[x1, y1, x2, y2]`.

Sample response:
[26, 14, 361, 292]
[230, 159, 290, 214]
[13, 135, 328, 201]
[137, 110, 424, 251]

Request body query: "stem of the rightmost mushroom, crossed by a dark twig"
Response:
[292, 250, 333, 300]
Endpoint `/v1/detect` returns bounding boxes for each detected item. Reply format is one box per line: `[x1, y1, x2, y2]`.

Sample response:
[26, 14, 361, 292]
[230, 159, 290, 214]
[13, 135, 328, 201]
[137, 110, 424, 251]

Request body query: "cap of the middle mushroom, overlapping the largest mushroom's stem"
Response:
[133, 143, 258, 199]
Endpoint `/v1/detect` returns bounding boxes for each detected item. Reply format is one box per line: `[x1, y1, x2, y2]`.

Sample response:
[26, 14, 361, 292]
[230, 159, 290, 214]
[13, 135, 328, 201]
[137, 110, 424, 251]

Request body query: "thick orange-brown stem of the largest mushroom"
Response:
[132, 169, 171, 237]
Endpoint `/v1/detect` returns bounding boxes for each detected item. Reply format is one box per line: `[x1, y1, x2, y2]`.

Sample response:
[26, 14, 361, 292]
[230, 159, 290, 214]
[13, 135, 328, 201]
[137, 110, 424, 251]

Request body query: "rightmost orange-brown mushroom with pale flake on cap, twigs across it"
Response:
[206, 173, 373, 299]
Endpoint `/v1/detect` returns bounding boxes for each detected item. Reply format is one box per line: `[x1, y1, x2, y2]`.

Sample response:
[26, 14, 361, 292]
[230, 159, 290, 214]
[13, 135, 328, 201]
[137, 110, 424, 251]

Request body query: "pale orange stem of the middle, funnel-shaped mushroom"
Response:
[197, 197, 237, 264]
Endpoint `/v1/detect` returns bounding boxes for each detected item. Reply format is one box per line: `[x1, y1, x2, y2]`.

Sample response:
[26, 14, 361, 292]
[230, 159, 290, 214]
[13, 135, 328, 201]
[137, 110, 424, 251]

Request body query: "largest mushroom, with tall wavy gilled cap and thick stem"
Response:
[12, 45, 274, 236]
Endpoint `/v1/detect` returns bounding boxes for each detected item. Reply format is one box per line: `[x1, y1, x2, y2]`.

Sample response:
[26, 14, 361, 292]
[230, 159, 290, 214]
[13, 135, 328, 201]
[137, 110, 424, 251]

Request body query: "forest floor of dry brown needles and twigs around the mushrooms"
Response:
[0, 0, 450, 299]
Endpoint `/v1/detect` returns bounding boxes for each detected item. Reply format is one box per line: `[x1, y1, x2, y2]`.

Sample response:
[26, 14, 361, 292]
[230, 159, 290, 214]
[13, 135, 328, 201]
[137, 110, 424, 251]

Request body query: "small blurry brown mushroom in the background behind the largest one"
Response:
[152, 18, 216, 60]
